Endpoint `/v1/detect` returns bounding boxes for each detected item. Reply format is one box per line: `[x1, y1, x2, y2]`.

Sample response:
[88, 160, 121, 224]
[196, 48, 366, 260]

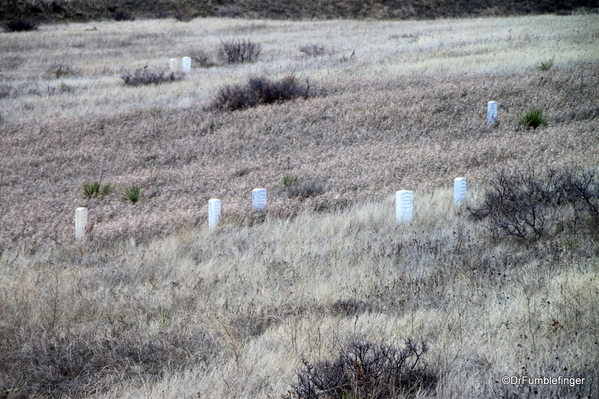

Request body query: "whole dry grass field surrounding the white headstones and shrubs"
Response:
[0, 14, 599, 399]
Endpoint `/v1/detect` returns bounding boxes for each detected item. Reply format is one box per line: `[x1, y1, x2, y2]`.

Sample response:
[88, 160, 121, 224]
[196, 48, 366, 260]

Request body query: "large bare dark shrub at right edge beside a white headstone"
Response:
[468, 167, 599, 243]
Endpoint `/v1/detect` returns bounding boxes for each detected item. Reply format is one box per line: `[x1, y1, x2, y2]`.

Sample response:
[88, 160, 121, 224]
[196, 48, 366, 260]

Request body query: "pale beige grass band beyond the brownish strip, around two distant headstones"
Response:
[0, 14, 599, 121]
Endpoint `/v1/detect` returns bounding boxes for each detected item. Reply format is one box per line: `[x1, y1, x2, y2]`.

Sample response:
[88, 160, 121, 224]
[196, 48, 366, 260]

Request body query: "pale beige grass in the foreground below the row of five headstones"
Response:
[0, 190, 599, 398]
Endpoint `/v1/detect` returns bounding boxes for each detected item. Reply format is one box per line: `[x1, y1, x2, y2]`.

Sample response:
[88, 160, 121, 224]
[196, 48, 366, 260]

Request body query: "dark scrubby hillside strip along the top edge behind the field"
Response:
[0, 0, 599, 22]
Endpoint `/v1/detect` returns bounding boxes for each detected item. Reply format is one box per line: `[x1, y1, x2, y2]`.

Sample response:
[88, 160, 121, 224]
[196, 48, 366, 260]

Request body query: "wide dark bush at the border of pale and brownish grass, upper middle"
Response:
[212, 75, 310, 111]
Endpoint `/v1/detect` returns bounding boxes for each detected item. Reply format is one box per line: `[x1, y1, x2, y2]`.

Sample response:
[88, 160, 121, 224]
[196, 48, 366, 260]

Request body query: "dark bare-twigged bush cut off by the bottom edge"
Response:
[286, 340, 438, 399]
